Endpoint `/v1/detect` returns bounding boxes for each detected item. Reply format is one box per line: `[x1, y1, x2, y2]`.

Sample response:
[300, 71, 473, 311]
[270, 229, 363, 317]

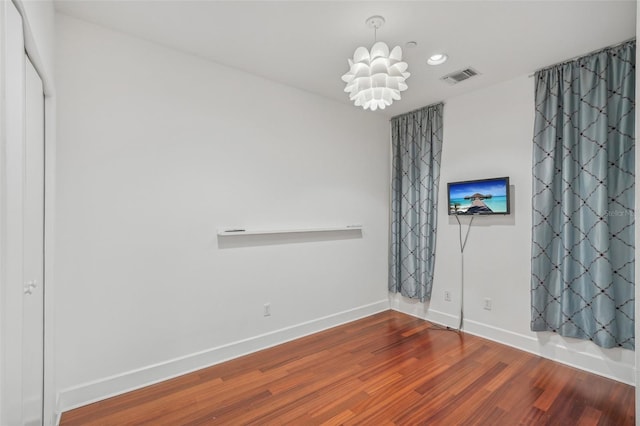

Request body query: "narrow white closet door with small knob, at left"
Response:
[22, 58, 45, 425]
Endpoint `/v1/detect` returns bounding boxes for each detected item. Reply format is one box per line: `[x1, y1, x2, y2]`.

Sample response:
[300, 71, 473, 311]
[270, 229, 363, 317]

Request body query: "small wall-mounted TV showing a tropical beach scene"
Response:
[447, 177, 509, 215]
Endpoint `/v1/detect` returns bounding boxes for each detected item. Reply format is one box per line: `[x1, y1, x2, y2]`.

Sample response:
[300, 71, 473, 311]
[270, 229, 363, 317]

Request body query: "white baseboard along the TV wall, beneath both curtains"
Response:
[391, 301, 636, 386]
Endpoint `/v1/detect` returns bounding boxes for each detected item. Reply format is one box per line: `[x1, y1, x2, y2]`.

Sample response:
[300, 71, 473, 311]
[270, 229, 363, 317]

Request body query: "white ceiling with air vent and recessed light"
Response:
[56, 0, 636, 116]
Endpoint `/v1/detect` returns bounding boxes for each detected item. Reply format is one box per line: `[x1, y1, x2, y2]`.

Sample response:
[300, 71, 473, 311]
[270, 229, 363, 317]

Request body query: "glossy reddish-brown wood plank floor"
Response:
[61, 311, 635, 426]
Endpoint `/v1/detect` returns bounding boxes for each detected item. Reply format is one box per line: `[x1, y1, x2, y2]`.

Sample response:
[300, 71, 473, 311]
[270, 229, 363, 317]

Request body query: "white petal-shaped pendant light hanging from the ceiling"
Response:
[342, 16, 411, 111]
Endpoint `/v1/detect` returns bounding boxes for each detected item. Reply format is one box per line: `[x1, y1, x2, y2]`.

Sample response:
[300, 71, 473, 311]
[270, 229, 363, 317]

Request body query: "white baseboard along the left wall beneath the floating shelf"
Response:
[58, 300, 389, 413]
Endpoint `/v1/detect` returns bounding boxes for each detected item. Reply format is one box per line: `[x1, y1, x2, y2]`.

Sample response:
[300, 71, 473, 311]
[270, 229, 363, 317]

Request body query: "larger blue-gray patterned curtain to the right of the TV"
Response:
[531, 41, 636, 349]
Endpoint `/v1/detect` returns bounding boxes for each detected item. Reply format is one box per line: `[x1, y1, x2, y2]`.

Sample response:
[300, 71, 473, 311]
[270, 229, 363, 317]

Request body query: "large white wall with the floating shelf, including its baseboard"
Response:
[56, 15, 389, 410]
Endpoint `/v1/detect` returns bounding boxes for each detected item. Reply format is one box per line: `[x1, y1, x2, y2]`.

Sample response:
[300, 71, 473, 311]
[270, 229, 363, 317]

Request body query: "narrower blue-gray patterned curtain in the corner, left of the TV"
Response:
[389, 104, 443, 302]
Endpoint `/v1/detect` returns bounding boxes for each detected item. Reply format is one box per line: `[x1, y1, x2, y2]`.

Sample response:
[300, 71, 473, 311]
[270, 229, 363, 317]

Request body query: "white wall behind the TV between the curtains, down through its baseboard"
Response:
[392, 76, 635, 383]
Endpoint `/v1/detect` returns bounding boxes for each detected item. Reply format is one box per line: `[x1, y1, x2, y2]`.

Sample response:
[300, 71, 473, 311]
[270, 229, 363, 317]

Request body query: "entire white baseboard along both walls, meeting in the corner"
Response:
[56, 300, 635, 424]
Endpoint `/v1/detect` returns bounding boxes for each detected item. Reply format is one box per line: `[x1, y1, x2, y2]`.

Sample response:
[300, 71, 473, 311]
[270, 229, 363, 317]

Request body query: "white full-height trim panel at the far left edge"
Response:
[0, 2, 25, 425]
